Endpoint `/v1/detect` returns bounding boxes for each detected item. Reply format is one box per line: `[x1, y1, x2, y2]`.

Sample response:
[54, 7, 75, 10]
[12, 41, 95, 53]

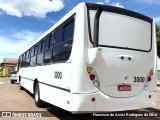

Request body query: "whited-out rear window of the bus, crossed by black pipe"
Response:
[89, 10, 152, 51]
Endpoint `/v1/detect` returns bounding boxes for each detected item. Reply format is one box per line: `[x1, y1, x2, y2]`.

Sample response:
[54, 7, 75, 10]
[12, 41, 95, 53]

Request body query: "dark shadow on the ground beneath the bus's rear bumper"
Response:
[47, 103, 160, 120]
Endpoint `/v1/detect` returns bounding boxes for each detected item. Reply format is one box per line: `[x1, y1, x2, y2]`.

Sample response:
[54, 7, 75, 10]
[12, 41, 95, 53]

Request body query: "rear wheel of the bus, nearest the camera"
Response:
[34, 83, 43, 107]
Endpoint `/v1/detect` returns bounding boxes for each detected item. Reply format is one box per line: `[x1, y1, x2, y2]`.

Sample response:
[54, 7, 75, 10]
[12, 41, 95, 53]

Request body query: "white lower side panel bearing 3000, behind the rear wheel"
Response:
[37, 63, 72, 110]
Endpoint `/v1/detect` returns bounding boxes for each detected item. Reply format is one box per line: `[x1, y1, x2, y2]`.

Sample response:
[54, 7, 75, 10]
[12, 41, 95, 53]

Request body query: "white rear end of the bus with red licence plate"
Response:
[87, 4, 157, 111]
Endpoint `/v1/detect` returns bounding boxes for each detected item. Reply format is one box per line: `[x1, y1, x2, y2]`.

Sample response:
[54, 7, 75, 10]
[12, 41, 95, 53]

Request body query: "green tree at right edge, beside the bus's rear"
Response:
[156, 25, 160, 57]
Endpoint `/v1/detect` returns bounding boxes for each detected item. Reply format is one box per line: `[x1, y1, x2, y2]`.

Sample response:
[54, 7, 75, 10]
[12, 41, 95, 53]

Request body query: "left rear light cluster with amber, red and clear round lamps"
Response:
[87, 67, 100, 88]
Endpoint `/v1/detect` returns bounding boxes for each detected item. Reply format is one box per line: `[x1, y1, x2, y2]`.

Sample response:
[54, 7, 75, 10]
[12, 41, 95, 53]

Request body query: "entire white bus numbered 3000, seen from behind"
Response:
[18, 3, 157, 112]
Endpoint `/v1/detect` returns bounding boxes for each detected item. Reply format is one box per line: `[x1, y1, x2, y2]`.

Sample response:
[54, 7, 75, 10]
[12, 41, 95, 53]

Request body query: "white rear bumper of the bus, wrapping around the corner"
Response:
[72, 90, 157, 113]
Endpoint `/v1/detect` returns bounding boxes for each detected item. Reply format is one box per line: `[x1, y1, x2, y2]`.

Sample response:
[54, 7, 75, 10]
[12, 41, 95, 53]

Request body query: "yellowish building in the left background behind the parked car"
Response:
[0, 58, 18, 76]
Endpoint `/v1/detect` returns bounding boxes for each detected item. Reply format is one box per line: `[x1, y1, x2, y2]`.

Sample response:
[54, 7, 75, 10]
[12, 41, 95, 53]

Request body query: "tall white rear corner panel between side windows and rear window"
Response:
[71, 4, 97, 93]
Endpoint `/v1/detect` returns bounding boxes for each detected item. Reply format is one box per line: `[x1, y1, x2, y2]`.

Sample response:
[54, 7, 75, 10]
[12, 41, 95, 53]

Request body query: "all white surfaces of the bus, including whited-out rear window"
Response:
[18, 3, 157, 112]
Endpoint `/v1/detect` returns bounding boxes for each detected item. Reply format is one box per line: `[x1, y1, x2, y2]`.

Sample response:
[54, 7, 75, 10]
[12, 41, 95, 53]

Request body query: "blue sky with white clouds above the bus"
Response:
[0, 0, 160, 62]
